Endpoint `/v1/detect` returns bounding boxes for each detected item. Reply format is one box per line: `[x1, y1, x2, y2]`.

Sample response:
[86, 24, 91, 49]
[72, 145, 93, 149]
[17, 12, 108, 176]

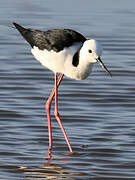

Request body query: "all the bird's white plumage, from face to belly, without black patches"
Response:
[31, 40, 102, 80]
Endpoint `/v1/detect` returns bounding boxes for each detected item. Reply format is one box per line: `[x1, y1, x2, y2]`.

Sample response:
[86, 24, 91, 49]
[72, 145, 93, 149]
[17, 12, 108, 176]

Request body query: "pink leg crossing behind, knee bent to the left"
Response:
[45, 74, 64, 158]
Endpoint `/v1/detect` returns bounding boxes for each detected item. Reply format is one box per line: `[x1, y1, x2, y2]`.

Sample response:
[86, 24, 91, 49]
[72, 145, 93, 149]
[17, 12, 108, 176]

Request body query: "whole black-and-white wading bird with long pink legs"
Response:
[13, 22, 112, 159]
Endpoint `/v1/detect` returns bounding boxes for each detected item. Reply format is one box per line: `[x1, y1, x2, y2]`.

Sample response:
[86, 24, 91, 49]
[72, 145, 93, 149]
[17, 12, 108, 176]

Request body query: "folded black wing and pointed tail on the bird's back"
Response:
[13, 23, 86, 52]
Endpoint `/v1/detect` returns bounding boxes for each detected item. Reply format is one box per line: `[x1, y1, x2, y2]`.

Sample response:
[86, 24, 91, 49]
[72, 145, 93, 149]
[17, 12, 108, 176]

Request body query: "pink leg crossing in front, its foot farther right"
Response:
[55, 73, 73, 153]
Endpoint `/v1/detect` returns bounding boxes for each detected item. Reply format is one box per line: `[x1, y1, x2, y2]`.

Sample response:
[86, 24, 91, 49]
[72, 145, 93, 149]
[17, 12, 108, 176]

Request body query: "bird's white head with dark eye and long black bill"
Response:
[80, 39, 112, 76]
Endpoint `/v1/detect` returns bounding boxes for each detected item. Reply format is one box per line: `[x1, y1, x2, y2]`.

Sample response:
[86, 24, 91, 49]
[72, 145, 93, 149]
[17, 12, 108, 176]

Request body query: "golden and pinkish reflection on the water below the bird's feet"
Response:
[16, 153, 88, 179]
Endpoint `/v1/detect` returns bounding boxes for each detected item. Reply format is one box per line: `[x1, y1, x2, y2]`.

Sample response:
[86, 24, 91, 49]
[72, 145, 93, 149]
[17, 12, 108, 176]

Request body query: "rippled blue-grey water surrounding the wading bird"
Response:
[0, 0, 135, 180]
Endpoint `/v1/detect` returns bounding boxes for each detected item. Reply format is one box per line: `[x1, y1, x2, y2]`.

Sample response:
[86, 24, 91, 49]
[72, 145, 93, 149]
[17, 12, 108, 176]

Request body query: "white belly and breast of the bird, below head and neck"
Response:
[31, 43, 92, 80]
